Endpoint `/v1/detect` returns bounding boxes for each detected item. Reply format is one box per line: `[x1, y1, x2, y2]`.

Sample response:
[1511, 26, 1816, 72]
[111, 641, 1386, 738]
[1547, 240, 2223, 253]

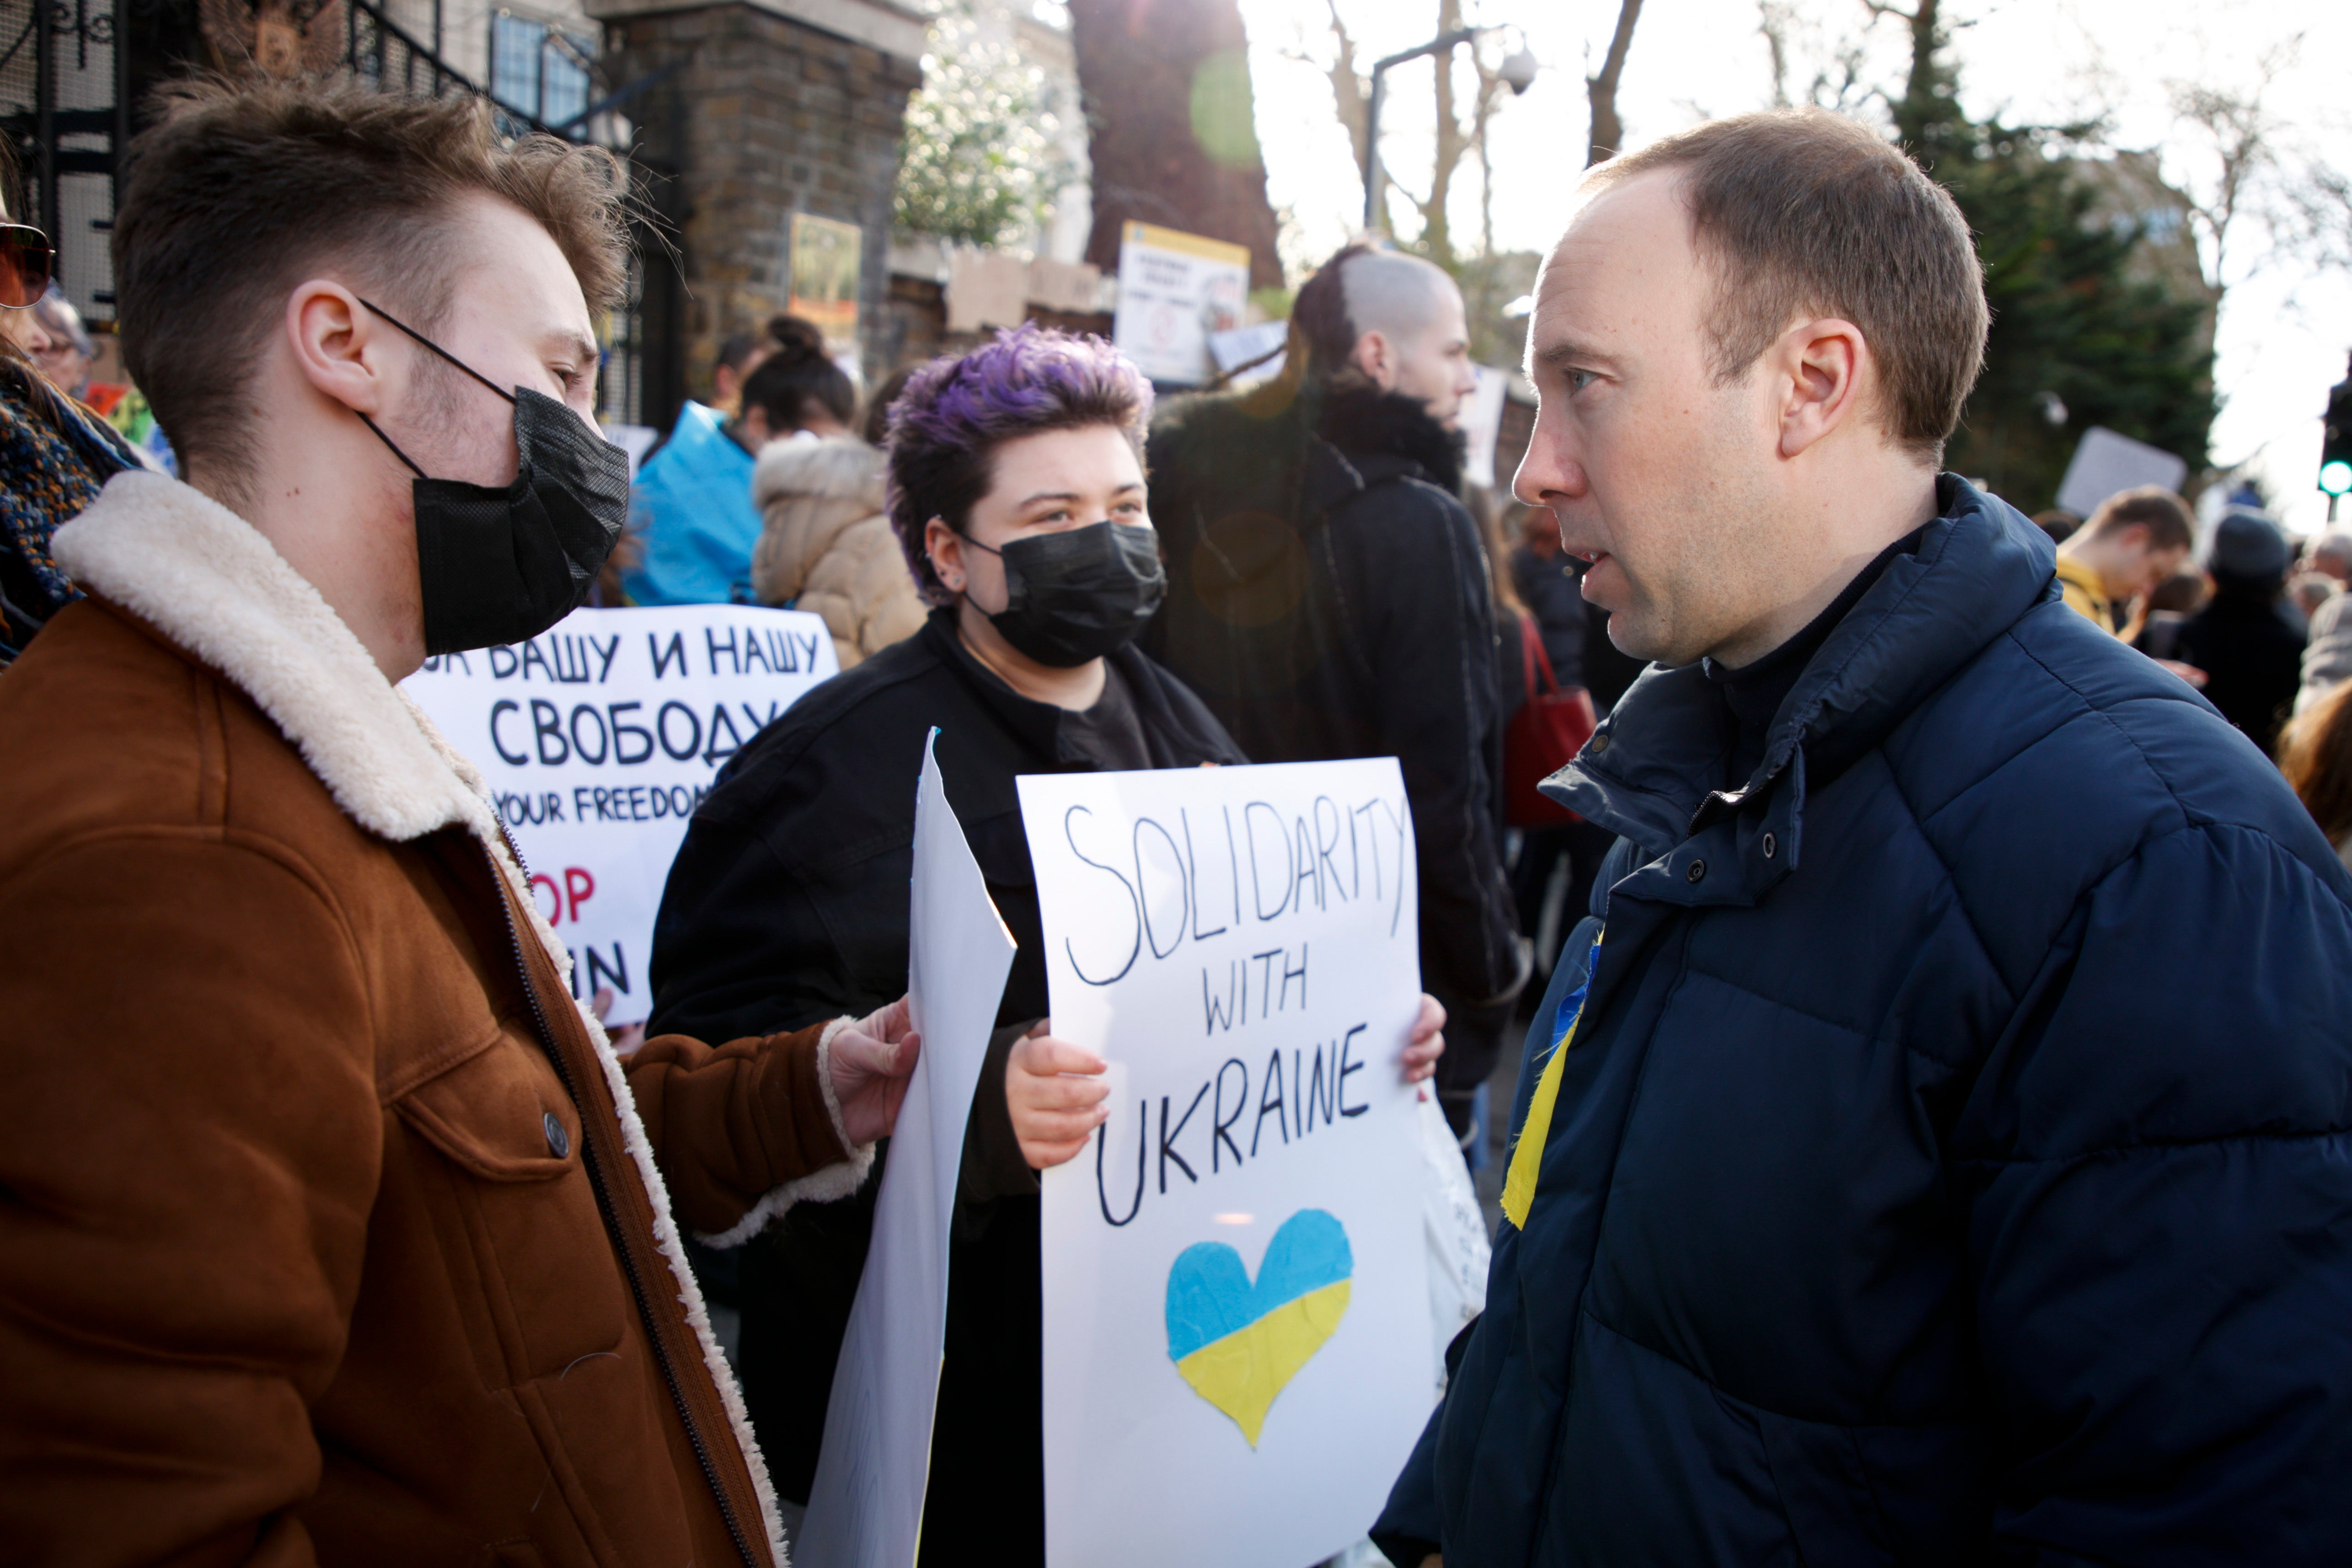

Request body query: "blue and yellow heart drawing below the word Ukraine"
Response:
[1167, 1208, 1355, 1448]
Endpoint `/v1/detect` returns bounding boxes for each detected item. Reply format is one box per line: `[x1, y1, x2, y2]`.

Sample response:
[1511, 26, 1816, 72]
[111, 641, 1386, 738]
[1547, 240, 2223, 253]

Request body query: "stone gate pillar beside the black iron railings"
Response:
[590, 0, 922, 426]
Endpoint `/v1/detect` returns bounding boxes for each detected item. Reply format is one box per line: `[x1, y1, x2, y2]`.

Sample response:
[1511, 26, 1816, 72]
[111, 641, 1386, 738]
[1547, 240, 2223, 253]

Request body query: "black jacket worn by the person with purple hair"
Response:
[649, 611, 1247, 1563]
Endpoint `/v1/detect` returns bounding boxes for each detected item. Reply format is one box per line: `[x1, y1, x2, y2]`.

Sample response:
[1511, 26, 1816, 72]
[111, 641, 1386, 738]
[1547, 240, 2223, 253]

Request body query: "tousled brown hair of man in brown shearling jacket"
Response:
[115, 78, 626, 487]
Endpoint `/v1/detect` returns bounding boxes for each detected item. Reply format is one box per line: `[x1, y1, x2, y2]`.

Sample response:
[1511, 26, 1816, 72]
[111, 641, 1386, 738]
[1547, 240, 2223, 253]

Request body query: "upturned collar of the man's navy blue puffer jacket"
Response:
[1543, 475, 2058, 903]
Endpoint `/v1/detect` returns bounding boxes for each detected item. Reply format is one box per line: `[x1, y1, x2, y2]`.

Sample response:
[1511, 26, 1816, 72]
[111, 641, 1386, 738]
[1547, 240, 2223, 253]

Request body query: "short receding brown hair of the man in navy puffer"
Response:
[1590, 108, 1992, 463]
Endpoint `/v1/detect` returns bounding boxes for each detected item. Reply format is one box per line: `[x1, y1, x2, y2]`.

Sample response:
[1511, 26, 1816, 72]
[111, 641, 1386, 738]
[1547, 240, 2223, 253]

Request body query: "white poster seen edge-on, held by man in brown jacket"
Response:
[793, 729, 1014, 1568]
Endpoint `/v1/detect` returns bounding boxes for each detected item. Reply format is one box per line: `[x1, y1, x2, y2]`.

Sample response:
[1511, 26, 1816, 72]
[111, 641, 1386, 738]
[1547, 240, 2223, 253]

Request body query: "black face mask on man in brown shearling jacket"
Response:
[360, 299, 628, 653]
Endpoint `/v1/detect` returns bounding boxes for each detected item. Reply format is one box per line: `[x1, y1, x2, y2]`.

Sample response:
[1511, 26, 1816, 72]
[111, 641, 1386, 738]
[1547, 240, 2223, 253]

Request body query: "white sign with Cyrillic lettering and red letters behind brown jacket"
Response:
[402, 604, 840, 1025]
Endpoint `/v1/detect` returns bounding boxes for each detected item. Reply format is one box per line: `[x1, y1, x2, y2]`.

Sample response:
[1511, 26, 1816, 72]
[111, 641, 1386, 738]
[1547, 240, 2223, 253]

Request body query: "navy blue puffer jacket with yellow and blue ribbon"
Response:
[1376, 477, 2352, 1568]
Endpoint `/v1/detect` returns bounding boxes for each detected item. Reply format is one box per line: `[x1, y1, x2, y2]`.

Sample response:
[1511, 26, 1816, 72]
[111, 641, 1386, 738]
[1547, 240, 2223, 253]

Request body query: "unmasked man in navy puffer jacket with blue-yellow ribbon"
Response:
[1374, 113, 2352, 1568]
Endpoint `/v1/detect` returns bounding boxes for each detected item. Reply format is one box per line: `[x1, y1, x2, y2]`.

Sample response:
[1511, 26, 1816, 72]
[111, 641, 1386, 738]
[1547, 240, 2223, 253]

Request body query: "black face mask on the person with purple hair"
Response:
[964, 522, 1169, 670]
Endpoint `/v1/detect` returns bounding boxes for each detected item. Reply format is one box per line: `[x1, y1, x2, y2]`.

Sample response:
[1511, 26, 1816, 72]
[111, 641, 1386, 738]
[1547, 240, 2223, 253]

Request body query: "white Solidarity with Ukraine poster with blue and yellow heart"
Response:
[1021, 757, 1432, 1568]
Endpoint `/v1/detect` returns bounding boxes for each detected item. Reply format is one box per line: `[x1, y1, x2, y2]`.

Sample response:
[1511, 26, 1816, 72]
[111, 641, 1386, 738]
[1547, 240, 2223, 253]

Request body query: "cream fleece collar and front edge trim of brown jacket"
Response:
[49, 472, 795, 1568]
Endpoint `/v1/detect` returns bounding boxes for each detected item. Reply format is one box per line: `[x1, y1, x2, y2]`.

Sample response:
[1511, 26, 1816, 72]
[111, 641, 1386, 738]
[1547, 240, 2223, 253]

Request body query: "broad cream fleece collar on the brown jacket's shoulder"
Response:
[52, 472, 498, 841]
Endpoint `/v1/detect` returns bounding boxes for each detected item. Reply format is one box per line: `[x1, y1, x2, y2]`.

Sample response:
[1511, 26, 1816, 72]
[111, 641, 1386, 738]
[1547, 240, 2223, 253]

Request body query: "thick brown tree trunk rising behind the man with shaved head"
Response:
[1070, 0, 1282, 289]
